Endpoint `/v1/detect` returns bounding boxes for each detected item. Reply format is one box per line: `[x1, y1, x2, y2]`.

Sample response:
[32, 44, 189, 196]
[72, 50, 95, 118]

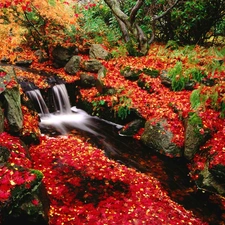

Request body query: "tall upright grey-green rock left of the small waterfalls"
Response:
[4, 87, 23, 133]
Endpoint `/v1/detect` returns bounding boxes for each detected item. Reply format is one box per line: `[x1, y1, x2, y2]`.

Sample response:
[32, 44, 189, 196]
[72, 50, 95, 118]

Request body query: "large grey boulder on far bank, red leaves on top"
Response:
[141, 119, 182, 157]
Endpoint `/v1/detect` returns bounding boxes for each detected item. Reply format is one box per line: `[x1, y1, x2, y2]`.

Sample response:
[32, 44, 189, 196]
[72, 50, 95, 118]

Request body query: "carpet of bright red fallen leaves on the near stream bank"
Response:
[30, 136, 206, 225]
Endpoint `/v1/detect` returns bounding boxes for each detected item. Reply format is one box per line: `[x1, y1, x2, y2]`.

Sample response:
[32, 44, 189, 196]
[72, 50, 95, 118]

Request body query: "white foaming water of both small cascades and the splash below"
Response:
[27, 84, 122, 135]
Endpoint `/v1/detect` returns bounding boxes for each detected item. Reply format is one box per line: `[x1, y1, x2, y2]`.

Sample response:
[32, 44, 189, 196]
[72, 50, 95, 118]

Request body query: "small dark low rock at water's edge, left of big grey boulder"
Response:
[119, 119, 145, 136]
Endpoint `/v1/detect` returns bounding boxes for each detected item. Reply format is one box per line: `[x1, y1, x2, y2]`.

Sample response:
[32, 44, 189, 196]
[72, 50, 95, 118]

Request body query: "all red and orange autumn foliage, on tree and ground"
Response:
[0, 0, 225, 225]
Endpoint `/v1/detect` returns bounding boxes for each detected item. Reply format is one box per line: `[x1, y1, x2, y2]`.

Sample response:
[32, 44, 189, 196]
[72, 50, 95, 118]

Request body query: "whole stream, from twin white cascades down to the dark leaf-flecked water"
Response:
[27, 84, 224, 225]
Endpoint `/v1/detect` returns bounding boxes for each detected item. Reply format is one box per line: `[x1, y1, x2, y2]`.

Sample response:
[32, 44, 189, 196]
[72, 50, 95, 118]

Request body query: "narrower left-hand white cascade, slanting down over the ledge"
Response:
[26, 89, 49, 115]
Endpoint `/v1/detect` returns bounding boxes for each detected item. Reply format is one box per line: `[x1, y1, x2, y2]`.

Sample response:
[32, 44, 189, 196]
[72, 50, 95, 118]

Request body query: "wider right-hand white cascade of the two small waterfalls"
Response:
[52, 84, 71, 114]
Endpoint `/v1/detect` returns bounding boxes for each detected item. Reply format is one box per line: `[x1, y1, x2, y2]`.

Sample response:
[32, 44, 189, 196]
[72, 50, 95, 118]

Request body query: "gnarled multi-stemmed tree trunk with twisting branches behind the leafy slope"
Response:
[104, 0, 180, 55]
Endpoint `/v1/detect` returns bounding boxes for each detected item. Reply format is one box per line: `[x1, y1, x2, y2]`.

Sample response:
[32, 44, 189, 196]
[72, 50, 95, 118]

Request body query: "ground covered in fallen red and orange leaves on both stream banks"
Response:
[2, 41, 225, 225]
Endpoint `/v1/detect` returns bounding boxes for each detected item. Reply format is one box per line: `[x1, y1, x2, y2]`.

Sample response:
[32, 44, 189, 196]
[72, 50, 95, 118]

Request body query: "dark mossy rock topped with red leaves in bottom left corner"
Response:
[0, 164, 49, 225]
